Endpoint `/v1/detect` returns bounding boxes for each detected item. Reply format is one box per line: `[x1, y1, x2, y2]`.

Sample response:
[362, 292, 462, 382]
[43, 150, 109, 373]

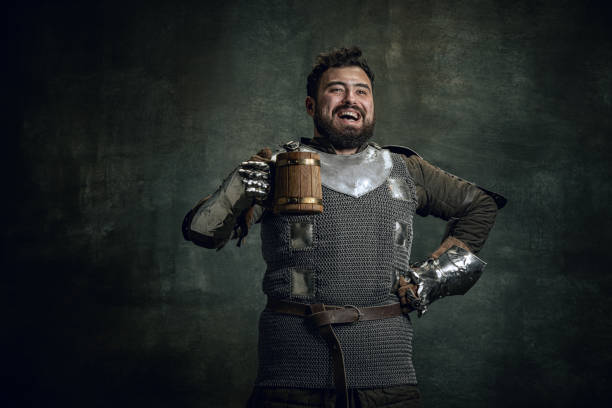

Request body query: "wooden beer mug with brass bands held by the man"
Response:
[274, 152, 323, 214]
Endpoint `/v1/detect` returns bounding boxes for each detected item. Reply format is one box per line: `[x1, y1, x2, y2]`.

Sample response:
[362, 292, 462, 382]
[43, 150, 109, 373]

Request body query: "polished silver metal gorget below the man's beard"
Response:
[300, 145, 393, 198]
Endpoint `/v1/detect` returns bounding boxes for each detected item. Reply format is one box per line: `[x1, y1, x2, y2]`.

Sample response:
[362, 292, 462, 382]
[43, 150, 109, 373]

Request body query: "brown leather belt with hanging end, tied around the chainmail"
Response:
[266, 298, 402, 408]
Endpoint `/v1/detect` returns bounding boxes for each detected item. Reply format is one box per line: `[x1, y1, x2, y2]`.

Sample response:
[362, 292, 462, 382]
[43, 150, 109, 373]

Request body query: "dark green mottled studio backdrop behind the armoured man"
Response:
[5, 0, 612, 407]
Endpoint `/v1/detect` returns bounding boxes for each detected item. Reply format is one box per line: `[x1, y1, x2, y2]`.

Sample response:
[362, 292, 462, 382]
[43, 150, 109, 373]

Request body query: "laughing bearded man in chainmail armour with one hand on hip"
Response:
[183, 47, 506, 407]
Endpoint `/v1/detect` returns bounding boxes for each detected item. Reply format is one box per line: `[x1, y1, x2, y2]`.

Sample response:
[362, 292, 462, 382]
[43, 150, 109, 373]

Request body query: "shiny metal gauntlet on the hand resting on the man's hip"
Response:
[408, 246, 486, 316]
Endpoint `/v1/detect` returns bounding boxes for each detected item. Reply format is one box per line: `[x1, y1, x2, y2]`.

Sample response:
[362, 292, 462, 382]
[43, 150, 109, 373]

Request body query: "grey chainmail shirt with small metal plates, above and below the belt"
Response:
[256, 147, 417, 388]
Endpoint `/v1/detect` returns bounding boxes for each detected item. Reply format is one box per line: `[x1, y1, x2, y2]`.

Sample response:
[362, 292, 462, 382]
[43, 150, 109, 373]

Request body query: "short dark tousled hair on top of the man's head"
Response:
[306, 47, 374, 100]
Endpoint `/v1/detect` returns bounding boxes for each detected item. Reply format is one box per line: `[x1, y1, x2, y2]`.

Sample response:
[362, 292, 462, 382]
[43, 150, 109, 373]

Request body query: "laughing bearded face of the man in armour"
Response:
[306, 66, 376, 149]
